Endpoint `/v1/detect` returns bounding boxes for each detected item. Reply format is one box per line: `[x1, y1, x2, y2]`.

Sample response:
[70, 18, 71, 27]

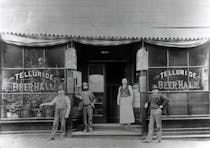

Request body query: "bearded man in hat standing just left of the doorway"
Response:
[75, 82, 96, 132]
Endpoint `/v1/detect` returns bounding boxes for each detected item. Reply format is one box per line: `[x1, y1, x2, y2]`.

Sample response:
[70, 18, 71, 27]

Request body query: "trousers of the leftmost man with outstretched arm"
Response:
[51, 109, 66, 137]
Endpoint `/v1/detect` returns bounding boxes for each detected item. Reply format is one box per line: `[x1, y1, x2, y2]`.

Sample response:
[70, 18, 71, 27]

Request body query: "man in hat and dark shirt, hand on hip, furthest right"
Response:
[142, 85, 168, 143]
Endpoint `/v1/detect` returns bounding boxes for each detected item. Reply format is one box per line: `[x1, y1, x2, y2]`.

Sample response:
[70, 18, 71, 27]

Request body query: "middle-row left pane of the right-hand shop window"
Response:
[149, 68, 168, 91]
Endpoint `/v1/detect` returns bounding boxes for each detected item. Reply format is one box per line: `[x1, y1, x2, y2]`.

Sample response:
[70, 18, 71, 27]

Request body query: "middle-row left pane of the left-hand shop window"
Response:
[2, 70, 24, 93]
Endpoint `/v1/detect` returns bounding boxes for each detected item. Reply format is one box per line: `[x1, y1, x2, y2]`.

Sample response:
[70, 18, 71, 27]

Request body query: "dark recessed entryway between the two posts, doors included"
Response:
[75, 43, 139, 123]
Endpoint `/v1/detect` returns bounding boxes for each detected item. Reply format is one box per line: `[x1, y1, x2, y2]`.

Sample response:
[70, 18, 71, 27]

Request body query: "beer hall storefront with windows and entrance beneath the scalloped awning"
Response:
[1, 37, 210, 131]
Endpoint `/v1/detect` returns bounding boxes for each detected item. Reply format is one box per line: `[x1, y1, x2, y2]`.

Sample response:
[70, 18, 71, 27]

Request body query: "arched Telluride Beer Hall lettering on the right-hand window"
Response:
[153, 69, 208, 90]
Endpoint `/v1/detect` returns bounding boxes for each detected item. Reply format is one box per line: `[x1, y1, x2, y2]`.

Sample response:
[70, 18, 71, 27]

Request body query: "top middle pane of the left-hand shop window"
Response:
[24, 48, 45, 68]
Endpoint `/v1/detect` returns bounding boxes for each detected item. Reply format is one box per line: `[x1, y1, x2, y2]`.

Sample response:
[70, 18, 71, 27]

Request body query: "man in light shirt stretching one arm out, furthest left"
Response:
[40, 89, 71, 140]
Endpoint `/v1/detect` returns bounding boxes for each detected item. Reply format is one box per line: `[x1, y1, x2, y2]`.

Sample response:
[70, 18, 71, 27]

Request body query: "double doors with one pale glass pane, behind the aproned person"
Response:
[88, 62, 125, 123]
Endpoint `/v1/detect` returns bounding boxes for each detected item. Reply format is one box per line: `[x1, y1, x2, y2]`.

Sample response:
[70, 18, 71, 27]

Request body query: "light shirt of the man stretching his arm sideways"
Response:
[52, 95, 70, 109]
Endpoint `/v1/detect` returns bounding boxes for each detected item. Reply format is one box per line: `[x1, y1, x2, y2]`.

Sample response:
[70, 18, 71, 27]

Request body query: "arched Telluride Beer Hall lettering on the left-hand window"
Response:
[4, 71, 57, 92]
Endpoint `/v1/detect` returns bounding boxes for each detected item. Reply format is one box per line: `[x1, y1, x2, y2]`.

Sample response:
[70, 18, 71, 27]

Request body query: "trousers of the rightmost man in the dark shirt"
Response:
[147, 108, 162, 141]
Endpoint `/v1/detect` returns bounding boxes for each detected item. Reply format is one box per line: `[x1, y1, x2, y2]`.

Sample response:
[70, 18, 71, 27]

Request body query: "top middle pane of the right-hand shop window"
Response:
[169, 48, 187, 66]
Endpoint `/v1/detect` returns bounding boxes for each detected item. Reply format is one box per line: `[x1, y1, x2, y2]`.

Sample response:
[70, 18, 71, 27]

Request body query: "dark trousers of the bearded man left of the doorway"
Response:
[82, 105, 93, 129]
